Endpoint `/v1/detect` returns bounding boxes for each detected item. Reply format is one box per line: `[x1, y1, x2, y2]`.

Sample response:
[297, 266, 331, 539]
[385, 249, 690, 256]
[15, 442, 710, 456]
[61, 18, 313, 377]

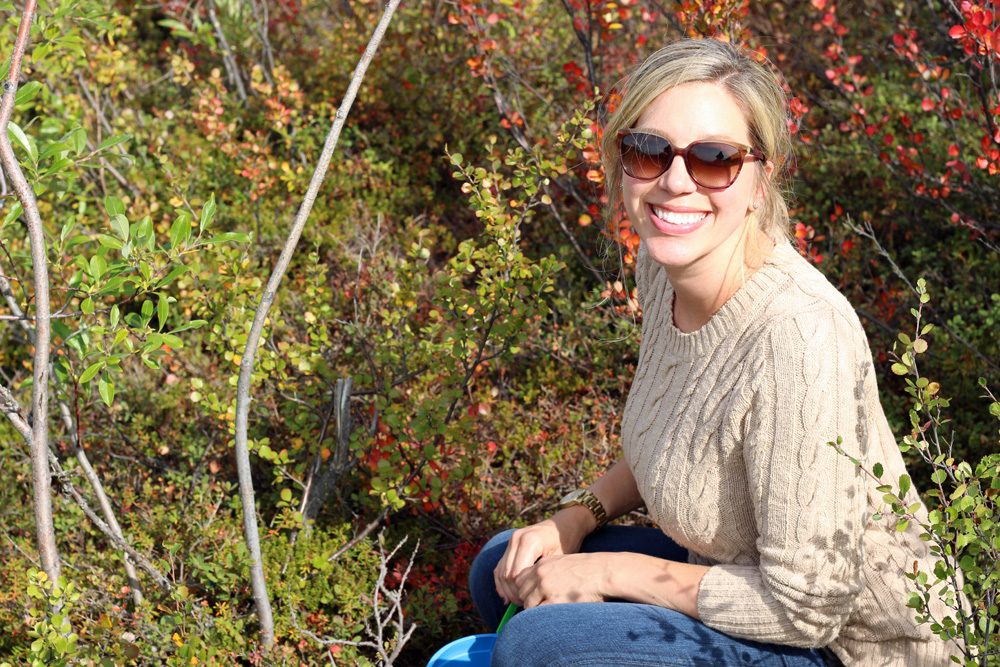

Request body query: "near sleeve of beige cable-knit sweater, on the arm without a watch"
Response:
[698, 305, 871, 647]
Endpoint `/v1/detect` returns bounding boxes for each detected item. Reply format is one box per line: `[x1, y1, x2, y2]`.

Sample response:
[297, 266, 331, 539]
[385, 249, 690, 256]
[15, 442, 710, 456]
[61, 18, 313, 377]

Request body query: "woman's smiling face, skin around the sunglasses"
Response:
[622, 82, 770, 280]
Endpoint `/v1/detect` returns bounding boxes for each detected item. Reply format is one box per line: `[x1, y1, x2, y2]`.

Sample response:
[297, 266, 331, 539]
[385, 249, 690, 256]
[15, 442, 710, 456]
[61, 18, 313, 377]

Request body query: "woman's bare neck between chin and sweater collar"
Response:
[667, 229, 774, 333]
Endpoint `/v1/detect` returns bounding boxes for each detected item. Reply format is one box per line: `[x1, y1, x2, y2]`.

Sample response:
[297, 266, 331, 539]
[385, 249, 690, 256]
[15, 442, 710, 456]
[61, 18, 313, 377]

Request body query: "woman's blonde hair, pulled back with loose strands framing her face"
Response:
[601, 39, 792, 243]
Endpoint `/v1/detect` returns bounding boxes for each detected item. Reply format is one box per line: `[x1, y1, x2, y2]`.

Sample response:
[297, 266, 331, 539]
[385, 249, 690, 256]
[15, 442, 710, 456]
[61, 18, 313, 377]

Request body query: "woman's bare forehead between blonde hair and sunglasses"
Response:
[634, 81, 750, 146]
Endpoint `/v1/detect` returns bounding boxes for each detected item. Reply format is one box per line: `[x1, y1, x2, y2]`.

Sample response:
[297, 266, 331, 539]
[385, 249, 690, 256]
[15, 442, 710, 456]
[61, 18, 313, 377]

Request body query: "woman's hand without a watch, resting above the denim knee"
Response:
[515, 553, 617, 609]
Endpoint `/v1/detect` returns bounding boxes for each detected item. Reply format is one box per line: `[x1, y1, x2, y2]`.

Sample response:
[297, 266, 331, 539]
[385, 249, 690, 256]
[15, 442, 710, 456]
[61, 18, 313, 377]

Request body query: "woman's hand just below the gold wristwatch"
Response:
[493, 505, 597, 606]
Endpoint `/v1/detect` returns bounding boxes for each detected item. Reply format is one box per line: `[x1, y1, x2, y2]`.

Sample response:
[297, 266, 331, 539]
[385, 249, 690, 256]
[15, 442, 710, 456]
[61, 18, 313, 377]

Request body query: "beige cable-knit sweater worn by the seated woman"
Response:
[622, 244, 952, 667]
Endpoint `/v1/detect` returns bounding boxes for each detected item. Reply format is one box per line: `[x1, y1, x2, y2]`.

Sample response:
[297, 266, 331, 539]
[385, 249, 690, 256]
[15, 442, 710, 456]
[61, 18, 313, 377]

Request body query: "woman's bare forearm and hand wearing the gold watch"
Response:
[494, 460, 642, 604]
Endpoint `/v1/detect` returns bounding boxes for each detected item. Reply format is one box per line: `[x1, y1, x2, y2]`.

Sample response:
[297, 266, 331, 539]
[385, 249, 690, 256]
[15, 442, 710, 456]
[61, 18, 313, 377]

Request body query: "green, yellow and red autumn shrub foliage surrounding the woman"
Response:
[0, 0, 1000, 665]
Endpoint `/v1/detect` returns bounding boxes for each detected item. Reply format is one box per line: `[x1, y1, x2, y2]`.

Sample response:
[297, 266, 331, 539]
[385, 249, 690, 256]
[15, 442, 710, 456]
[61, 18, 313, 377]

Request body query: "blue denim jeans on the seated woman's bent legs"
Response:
[469, 526, 827, 667]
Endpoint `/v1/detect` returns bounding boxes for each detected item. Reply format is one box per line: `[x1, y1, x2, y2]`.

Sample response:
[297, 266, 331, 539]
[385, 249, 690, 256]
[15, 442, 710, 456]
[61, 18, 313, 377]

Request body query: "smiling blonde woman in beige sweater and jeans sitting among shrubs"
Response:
[471, 40, 950, 667]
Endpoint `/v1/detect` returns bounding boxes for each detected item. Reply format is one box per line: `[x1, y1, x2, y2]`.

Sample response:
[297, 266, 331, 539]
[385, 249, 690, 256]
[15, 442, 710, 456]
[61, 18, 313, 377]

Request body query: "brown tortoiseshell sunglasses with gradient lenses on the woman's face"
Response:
[618, 130, 764, 190]
